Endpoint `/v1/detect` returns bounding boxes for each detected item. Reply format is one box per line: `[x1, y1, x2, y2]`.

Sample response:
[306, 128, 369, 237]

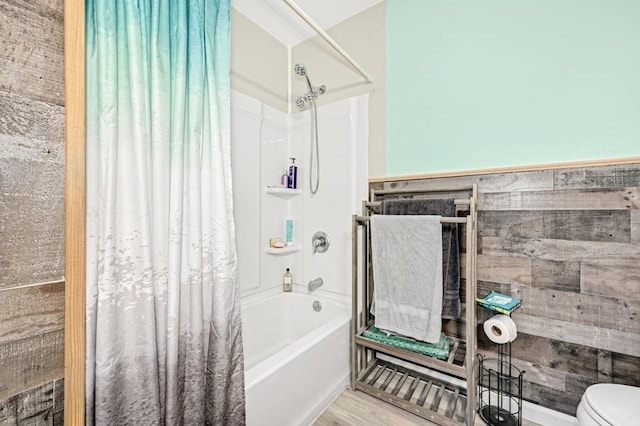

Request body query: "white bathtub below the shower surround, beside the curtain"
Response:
[241, 289, 350, 426]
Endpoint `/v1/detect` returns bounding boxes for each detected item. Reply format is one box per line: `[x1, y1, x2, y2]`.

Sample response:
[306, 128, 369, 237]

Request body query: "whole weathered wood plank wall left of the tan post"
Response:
[0, 0, 65, 425]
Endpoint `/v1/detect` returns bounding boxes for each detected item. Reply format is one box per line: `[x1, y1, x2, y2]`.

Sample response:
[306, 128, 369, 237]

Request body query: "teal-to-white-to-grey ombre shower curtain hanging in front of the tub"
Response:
[86, 0, 245, 425]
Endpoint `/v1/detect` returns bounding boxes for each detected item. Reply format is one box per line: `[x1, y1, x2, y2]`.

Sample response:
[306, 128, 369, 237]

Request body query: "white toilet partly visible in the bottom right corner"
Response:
[576, 383, 640, 426]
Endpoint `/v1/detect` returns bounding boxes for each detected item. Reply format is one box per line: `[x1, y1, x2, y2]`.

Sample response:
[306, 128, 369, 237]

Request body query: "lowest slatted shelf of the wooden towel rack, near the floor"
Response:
[355, 359, 467, 426]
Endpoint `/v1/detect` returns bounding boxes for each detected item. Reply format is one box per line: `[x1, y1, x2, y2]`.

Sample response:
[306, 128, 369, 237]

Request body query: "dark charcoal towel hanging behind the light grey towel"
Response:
[382, 198, 461, 319]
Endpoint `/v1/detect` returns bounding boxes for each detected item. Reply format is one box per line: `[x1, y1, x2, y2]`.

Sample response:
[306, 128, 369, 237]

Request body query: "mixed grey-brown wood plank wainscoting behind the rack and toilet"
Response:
[371, 163, 640, 415]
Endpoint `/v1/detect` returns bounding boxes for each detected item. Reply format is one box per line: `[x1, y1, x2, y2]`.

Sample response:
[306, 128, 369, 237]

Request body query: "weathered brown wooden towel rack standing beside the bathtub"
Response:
[351, 184, 478, 425]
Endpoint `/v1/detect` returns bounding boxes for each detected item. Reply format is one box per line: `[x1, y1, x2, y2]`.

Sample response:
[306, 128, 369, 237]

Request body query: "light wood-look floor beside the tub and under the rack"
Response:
[313, 388, 536, 426]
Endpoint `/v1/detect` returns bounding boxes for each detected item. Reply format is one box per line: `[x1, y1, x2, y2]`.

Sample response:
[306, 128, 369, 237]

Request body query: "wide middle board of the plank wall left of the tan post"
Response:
[0, 91, 64, 288]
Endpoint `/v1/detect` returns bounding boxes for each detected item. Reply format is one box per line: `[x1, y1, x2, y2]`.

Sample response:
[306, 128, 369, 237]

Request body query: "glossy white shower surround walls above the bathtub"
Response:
[231, 92, 368, 299]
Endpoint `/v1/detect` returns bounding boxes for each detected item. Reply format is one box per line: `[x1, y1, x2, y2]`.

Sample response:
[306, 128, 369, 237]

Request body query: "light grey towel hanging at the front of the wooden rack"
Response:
[371, 215, 442, 343]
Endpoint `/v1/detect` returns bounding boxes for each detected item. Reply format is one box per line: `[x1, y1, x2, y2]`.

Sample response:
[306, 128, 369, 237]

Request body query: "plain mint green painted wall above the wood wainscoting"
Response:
[385, 0, 640, 176]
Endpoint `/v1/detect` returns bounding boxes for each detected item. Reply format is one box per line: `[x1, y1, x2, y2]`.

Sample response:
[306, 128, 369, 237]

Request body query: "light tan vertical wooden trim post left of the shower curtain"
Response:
[64, 0, 86, 426]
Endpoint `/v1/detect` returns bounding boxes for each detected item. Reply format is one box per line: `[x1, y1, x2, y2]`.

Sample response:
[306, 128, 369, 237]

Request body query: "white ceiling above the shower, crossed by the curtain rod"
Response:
[232, 0, 383, 47]
